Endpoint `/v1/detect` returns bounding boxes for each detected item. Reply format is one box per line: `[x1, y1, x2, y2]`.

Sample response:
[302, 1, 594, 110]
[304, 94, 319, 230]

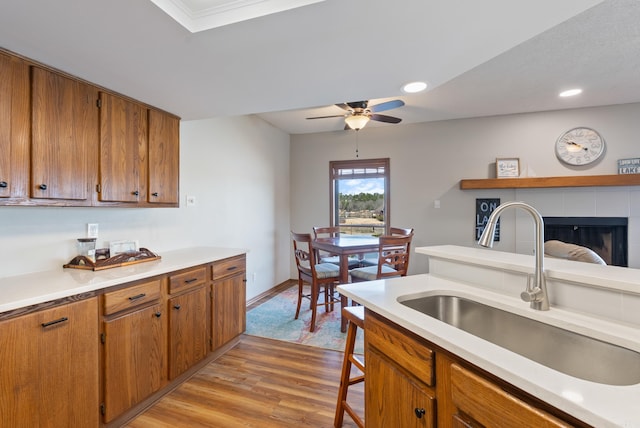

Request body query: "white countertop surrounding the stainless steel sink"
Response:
[338, 274, 640, 428]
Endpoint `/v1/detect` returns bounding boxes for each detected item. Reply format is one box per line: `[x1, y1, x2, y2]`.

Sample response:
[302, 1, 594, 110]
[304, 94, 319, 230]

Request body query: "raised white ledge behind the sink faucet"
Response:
[415, 245, 640, 294]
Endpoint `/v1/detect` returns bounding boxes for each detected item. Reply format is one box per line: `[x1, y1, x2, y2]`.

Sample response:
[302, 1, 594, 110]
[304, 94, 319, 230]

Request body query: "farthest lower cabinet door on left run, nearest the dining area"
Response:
[211, 272, 247, 349]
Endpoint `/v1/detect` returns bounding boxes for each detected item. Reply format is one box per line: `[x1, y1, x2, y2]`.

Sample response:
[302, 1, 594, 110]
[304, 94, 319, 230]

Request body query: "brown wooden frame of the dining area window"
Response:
[329, 158, 391, 234]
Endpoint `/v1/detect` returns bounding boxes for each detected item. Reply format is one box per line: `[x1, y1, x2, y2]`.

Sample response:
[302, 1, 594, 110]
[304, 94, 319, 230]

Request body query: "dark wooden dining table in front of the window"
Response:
[313, 234, 380, 333]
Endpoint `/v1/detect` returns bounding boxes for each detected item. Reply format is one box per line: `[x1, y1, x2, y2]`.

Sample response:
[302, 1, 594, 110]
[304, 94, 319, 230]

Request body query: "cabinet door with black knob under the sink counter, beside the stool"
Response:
[365, 348, 435, 428]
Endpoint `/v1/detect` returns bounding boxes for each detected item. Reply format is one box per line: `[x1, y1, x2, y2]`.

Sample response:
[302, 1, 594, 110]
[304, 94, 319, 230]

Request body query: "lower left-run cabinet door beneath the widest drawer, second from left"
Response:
[103, 305, 167, 422]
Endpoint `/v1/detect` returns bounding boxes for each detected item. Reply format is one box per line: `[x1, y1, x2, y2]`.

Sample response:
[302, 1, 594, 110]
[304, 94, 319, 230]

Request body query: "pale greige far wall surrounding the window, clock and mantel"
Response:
[291, 104, 640, 275]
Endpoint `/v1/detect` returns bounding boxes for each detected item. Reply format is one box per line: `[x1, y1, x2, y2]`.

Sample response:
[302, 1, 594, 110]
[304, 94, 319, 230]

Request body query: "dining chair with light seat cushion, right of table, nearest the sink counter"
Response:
[349, 233, 413, 282]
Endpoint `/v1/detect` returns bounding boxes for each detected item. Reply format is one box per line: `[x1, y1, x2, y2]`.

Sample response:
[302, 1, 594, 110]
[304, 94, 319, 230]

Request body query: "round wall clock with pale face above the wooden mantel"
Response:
[556, 127, 605, 165]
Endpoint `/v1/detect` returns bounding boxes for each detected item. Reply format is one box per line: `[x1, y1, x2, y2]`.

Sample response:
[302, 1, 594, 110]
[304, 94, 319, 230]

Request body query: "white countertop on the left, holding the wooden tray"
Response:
[0, 247, 247, 313]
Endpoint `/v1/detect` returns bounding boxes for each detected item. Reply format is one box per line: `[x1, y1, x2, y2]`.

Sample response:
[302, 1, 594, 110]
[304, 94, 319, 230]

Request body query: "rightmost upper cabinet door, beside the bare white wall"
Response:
[149, 109, 180, 204]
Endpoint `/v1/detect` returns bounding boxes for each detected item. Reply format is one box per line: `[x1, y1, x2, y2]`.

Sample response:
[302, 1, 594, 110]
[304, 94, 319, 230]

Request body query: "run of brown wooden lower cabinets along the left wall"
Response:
[0, 255, 246, 428]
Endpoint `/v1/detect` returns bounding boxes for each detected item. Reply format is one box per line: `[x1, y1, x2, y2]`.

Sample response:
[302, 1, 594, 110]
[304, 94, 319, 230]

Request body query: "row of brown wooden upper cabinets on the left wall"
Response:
[0, 49, 180, 207]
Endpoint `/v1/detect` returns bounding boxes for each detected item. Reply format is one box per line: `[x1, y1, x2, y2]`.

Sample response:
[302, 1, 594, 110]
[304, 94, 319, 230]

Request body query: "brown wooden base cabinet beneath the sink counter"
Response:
[365, 310, 589, 428]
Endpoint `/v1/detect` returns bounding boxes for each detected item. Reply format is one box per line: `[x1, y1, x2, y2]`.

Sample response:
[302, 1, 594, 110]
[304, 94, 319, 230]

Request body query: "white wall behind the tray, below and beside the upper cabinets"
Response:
[0, 117, 290, 298]
